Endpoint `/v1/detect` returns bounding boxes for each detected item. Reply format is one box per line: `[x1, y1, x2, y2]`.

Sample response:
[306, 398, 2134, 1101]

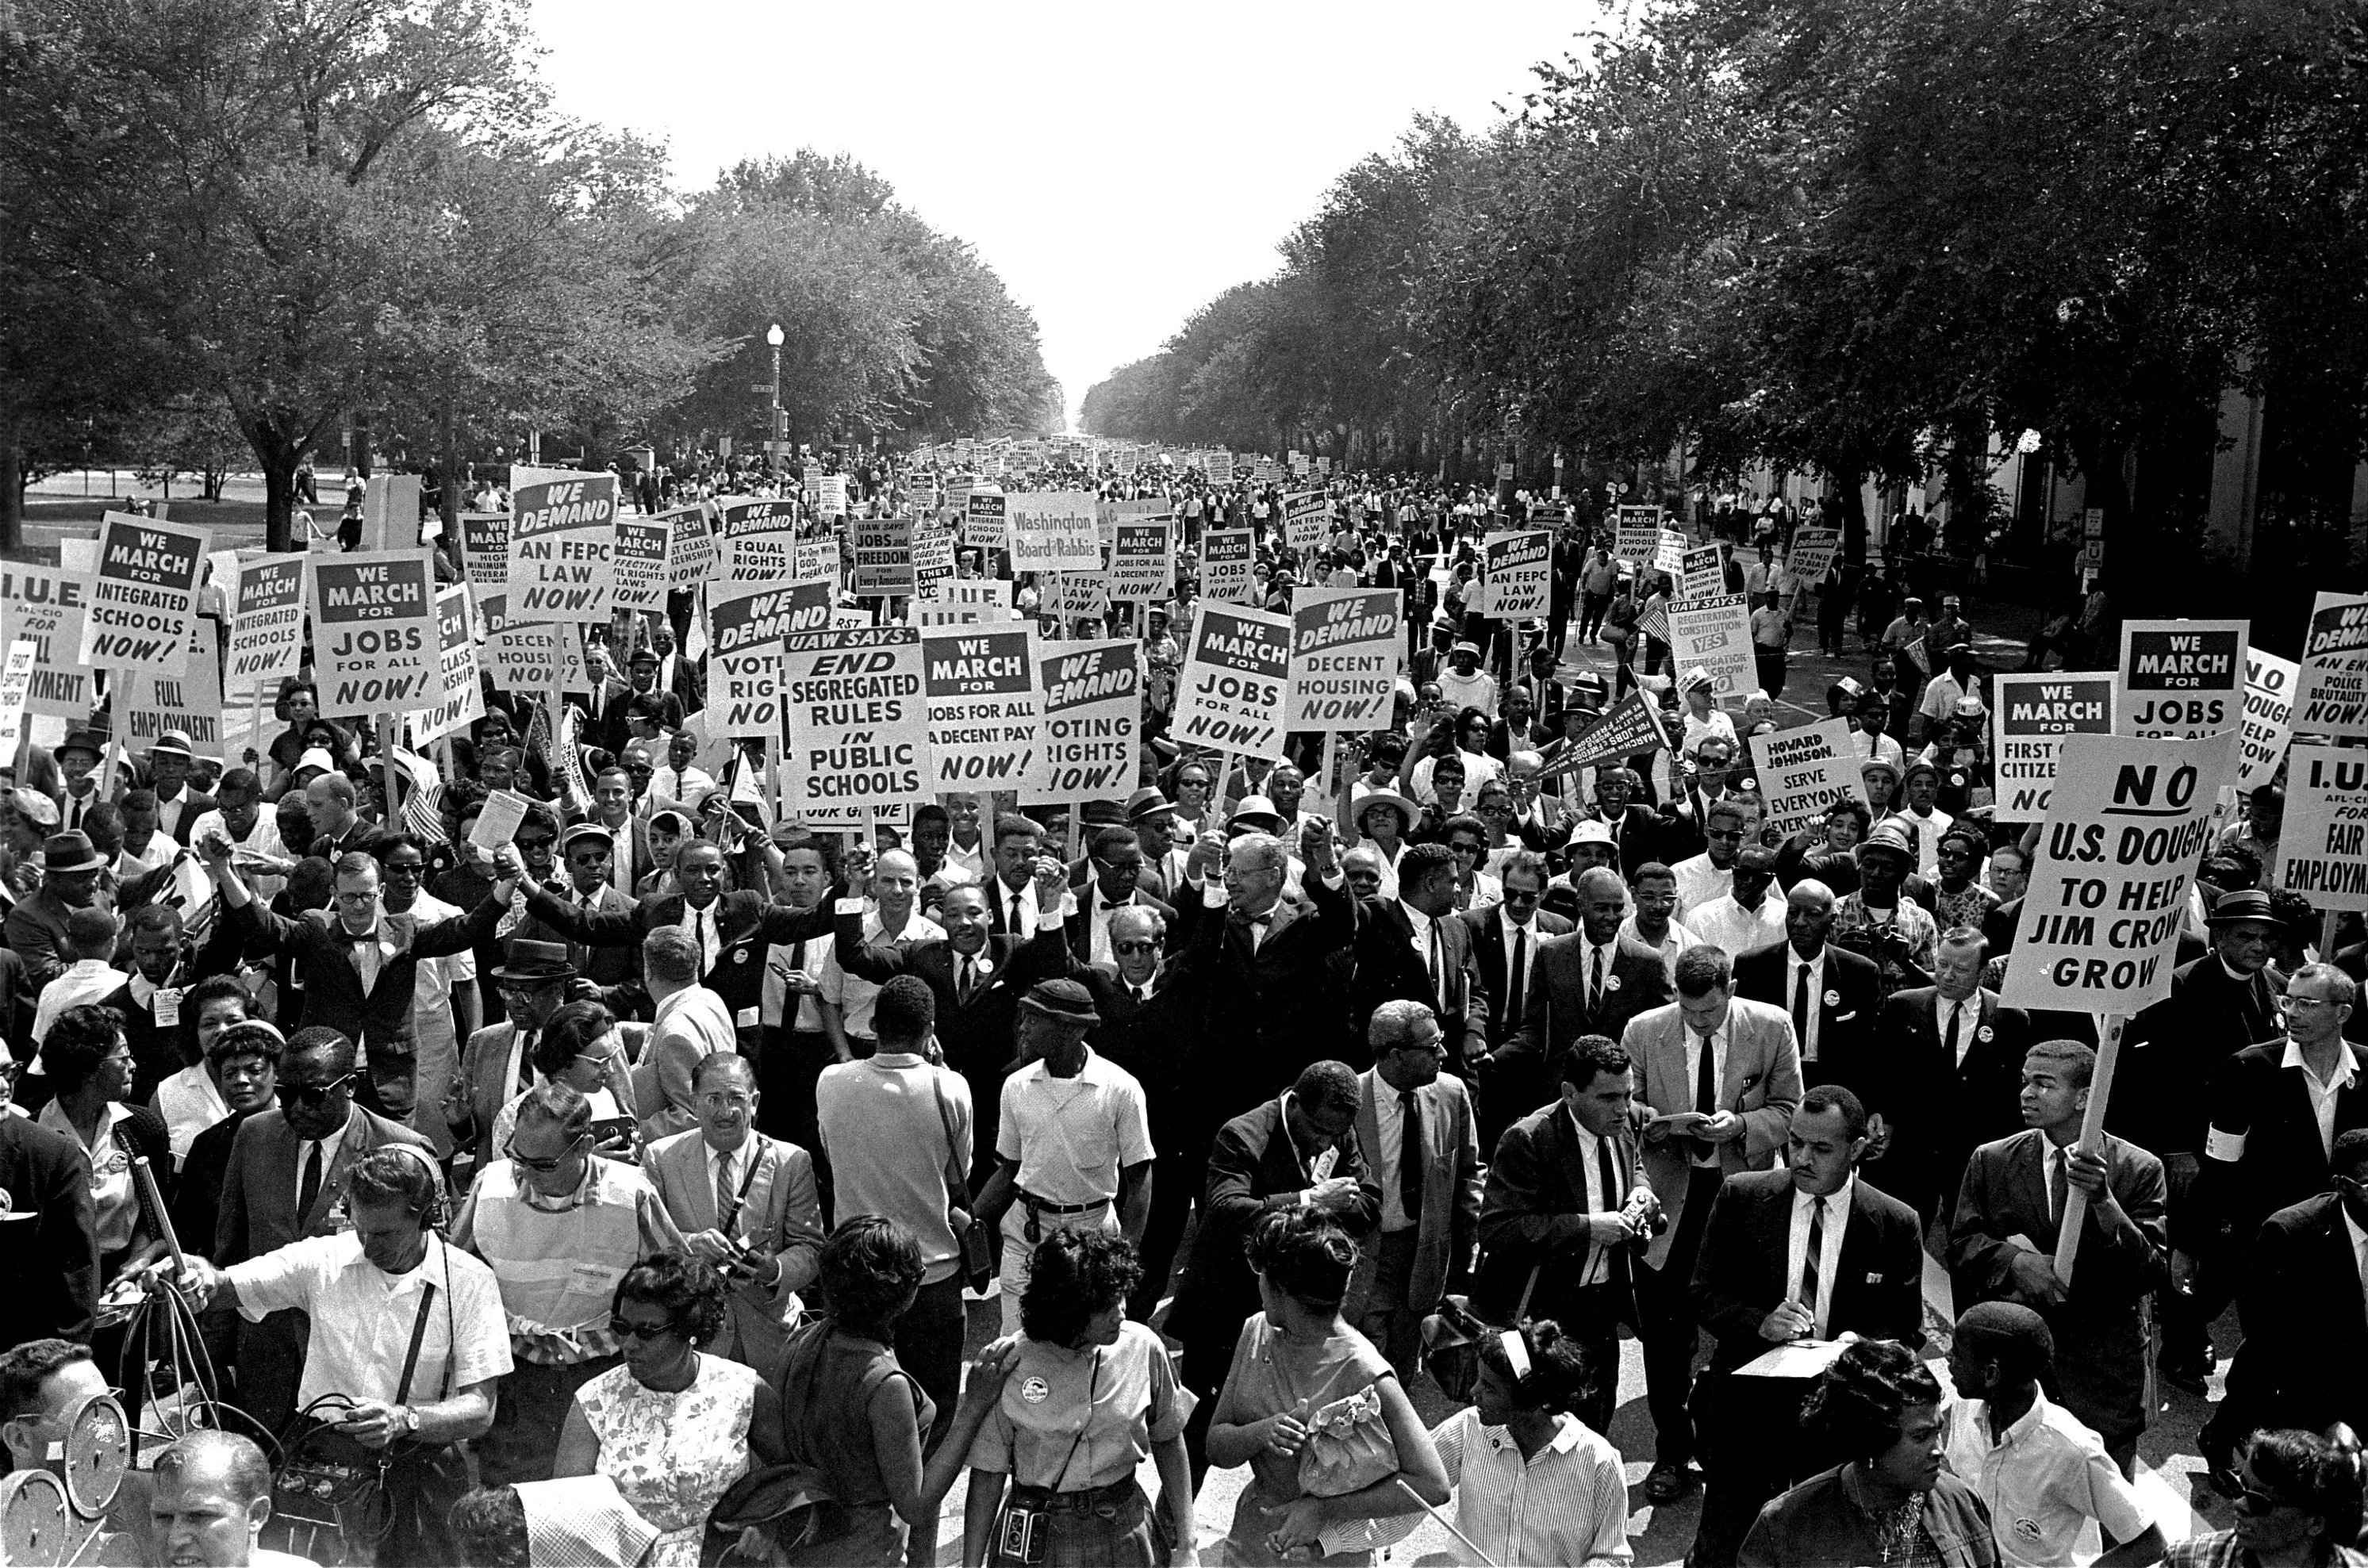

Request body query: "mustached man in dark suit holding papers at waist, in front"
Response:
[1686, 1085, 1923, 1568]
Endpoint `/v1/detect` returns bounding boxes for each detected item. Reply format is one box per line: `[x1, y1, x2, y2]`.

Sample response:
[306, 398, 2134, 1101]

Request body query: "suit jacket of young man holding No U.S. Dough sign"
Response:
[1949, 1128, 2169, 1447]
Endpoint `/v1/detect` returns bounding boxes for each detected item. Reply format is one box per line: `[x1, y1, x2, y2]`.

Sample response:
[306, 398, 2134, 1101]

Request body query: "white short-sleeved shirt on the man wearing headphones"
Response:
[223, 1232, 512, 1407]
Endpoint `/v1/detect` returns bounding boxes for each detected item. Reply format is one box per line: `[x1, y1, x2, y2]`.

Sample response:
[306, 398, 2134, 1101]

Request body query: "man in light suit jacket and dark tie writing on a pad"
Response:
[1620, 948, 1800, 1501]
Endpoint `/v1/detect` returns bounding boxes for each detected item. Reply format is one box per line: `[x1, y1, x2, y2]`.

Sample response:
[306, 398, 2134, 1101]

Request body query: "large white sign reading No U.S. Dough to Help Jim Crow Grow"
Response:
[2001, 730, 2236, 1014]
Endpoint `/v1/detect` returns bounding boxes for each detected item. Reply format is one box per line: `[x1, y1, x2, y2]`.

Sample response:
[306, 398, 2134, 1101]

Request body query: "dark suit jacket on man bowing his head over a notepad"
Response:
[1168, 1098, 1380, 1345]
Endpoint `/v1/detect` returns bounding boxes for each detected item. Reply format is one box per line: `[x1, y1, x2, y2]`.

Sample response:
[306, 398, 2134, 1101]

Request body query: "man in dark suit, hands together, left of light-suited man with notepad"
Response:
[1473, 1035, 1658, 1433]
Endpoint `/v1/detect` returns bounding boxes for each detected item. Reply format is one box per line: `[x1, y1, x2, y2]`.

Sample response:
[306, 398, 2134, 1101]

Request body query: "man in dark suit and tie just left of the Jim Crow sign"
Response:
[1852, 926, 2032, 1220]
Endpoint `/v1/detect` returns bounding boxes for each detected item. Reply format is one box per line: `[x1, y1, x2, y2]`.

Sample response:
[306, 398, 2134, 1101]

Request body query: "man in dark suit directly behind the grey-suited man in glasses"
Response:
[1342, 843, 1487, 1071]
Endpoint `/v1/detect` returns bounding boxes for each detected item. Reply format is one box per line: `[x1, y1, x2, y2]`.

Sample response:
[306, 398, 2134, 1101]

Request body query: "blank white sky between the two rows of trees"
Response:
[533, 0, 1601, 431]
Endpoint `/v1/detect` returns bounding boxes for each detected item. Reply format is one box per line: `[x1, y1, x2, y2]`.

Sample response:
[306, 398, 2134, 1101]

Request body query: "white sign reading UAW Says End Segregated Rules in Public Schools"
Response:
[777, 625, 933, 819]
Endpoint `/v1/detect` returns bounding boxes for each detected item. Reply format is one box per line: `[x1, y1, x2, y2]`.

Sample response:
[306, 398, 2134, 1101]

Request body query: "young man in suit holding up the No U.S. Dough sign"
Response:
[1949, 1040, 2169, 1474]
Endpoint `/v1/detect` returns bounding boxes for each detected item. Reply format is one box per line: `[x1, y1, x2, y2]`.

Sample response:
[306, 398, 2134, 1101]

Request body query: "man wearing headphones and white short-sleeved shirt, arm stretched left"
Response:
[167, 1144, 512, 1568]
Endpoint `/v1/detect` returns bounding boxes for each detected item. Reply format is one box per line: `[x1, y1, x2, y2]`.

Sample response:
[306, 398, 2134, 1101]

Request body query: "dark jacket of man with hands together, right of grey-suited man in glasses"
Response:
[1473, 1102, 1651, 1321]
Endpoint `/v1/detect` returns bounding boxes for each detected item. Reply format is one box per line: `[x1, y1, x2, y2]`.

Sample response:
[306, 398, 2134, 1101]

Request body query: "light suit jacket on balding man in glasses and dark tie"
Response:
[642, 1128, 822, 1378]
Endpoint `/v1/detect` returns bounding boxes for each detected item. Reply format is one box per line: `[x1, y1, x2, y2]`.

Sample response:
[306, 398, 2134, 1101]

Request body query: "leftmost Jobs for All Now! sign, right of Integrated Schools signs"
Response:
[305, 550, 440, 718]
